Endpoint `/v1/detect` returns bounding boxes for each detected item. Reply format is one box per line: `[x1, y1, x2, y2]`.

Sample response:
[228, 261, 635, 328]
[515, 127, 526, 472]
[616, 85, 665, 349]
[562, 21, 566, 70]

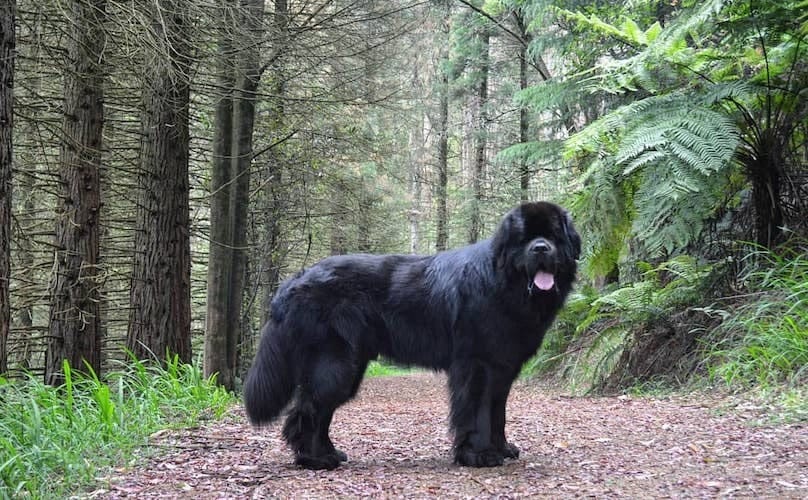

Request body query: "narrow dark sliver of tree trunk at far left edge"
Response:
[0, 0, 17, 375]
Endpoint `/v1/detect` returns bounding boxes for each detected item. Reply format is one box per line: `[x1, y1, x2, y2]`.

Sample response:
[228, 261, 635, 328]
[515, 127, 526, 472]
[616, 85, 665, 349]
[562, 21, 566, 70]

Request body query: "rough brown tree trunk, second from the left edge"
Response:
[45, 0, 106, 385]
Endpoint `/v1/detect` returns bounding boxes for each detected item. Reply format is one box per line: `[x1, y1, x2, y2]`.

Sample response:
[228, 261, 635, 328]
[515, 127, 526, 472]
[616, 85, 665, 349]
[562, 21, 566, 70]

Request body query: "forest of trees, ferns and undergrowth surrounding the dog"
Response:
[0, 0, 808, 498]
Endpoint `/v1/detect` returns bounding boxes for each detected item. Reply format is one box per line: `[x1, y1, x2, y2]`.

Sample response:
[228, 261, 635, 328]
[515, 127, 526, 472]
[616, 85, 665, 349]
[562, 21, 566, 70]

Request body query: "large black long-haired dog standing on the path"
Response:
[244, 202, 581, 469]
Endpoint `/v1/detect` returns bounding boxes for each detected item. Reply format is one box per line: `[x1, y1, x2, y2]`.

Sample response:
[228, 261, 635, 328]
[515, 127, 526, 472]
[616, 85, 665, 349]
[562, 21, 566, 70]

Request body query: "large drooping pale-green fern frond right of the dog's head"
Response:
[566, 64, 740, 260]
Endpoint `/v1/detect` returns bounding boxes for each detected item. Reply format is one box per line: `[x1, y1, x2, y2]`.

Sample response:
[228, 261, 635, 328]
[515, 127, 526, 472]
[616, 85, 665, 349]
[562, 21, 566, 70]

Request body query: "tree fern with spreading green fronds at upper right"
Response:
[548, 0, 806, 270]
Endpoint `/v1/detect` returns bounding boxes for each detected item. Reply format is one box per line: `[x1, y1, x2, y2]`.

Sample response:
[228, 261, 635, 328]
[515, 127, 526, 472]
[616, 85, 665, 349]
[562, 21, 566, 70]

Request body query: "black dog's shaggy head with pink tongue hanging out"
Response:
[493, 201, 581, 293]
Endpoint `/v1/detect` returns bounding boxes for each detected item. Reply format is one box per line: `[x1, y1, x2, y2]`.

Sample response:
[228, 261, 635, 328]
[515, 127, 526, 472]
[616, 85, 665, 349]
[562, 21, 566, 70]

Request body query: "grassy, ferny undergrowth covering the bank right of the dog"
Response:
[523, 245, 808, 404]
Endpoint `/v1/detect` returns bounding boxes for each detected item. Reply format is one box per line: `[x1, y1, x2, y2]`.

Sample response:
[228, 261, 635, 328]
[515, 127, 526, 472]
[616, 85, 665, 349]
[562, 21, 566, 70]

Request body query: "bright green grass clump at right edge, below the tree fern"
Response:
[704, 249, 808, 387]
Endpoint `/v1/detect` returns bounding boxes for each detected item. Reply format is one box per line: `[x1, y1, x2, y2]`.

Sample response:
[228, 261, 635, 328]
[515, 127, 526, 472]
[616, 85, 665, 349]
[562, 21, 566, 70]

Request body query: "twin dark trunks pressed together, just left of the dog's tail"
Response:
[205, 0, 263, 390]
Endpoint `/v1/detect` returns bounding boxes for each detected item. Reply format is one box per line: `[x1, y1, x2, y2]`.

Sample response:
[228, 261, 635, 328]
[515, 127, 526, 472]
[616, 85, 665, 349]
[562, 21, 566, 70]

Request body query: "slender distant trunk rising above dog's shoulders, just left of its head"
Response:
[469, 27, 490, 243]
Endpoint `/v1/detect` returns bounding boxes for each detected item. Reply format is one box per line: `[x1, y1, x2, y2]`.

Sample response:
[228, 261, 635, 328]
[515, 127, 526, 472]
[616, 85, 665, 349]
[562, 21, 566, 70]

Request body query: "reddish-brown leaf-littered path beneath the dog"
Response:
[90, 374, 808, 499]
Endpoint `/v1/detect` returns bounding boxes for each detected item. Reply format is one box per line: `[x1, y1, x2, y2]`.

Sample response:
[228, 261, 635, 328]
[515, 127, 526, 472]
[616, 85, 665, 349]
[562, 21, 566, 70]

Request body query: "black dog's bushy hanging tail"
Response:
[244, 320, 296, 425]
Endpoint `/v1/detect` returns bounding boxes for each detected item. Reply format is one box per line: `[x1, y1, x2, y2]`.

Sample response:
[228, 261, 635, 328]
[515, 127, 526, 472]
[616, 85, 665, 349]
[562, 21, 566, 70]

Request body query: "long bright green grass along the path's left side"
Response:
[0, 357, 235, 498]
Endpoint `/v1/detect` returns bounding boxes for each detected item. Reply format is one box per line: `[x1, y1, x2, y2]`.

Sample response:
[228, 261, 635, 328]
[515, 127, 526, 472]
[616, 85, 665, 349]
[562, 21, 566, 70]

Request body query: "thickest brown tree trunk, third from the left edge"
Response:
[127, 0, 191, 363]
